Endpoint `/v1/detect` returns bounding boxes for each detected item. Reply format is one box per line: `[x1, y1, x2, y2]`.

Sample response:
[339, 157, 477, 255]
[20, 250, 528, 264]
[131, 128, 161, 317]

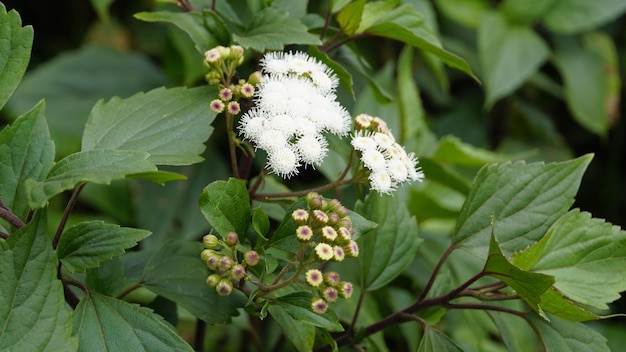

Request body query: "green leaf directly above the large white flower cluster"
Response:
[233, 7, 322, 52]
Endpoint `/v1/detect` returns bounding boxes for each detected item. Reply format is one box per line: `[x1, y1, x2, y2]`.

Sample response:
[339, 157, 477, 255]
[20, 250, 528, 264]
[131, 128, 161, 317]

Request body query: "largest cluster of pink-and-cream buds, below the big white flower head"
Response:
[291, 192, 359, 314]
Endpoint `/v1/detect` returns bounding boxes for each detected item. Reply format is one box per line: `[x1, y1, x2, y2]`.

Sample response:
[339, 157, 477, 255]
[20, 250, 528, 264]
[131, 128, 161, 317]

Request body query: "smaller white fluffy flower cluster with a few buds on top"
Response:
[350, 114, 424, 193]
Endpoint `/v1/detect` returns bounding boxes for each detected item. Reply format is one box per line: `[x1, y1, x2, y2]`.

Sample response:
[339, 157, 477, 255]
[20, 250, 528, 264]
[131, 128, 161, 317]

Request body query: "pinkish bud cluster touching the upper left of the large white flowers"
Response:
[204, 45, 261, 115]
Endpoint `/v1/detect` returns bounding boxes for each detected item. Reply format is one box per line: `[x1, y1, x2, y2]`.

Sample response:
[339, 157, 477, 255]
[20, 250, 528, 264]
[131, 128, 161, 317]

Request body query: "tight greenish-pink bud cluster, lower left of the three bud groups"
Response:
[200, 232, 259, 296]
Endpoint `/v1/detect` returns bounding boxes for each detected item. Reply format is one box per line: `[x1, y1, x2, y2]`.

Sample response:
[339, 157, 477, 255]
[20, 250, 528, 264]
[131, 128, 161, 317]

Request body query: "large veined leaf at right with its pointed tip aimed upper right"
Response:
[453, 155, 592, 258]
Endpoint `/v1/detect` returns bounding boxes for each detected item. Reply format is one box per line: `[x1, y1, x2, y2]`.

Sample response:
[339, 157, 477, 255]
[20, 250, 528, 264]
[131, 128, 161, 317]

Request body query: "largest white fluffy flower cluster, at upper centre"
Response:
[239, 52, 351, 178]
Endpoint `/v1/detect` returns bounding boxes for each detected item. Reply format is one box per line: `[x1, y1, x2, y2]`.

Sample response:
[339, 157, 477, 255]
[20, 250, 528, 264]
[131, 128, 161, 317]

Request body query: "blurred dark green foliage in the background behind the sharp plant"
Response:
[0, 0, 626, 350]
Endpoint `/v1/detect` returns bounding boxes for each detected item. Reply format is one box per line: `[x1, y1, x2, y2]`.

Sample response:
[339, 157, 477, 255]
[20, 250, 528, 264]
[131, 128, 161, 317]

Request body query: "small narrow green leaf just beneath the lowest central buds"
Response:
[274, 292, 343, 332]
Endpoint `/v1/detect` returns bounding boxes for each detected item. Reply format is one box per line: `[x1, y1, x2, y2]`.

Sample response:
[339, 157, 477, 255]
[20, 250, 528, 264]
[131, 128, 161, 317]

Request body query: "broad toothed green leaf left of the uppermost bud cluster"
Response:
[82, 87, 216, 165]
